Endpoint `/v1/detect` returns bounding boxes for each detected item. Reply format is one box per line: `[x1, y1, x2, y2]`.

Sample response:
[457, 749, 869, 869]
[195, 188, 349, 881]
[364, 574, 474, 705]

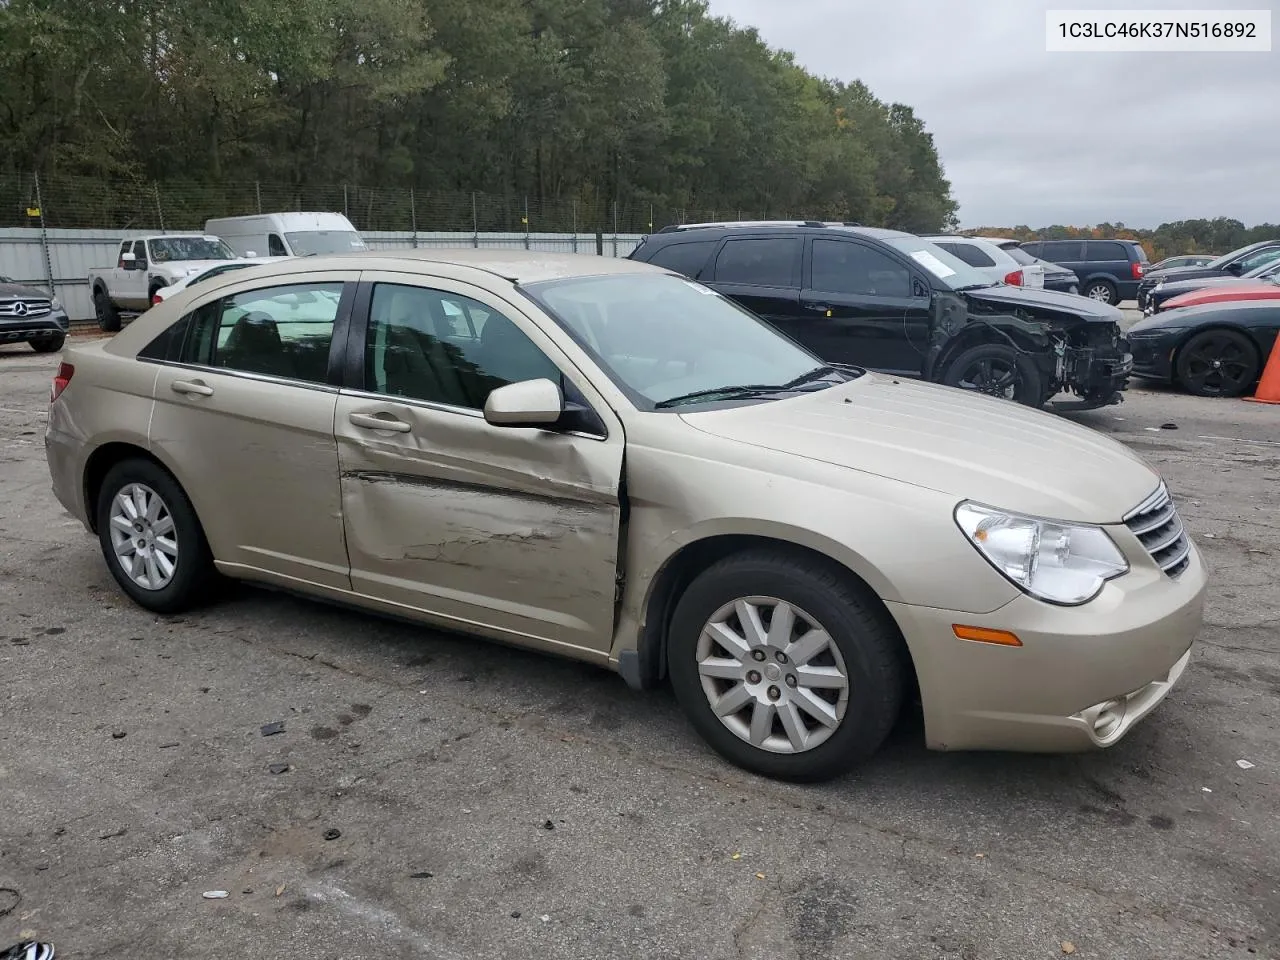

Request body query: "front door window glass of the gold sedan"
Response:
[365, 283, 563, 410]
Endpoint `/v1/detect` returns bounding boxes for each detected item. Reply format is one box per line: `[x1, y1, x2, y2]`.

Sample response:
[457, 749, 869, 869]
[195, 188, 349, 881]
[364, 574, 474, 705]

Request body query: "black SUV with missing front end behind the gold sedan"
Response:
[630, 220, 1132, 407]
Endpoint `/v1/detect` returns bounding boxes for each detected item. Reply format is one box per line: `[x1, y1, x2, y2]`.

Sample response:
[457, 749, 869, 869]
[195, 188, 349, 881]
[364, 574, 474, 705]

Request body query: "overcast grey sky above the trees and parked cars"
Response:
[710, 0, 1280, 227]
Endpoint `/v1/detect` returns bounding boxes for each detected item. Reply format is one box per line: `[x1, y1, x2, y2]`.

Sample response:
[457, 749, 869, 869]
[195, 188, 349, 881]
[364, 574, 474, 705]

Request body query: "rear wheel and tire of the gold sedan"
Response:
[97, 460, 216, 613]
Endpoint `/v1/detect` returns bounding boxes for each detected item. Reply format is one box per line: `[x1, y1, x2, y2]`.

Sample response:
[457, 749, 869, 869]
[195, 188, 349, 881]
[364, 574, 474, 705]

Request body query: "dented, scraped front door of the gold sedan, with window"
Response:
[334, 273, 623, 654]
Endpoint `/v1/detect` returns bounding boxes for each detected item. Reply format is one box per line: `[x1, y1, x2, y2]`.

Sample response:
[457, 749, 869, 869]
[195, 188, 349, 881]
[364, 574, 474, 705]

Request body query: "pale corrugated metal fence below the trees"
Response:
[0, 227, 643, 320]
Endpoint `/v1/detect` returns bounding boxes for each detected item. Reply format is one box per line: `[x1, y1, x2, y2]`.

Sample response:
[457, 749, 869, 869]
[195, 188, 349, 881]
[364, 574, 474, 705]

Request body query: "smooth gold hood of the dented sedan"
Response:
[681, 374, 1160, 524]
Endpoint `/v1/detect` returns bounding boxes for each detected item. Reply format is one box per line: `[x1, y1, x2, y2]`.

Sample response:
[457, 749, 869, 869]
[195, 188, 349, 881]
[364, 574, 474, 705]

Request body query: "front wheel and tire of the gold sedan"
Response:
[667, 550, 904, 781]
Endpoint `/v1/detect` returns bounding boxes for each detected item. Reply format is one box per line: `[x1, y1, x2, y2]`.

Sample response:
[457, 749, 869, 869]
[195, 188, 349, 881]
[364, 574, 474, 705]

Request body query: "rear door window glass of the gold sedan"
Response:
[183, 283, 343, 383]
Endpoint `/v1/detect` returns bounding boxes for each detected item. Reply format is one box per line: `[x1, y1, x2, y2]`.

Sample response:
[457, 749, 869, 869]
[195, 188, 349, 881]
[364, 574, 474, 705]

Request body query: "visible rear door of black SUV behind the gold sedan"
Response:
[703, 233, 804, 333]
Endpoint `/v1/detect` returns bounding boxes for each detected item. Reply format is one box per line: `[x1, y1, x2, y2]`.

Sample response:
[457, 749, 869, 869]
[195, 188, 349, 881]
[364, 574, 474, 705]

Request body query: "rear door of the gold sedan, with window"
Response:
[150, 274, 356, 590]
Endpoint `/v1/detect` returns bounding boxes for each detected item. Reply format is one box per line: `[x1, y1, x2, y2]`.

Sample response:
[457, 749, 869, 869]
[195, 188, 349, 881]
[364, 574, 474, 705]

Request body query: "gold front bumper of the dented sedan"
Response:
[887, 527, 1207, 753]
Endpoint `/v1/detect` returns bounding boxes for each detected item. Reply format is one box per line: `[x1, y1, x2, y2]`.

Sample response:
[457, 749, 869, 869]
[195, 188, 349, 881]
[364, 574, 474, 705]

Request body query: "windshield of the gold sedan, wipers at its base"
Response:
[521, 274, 861, 410]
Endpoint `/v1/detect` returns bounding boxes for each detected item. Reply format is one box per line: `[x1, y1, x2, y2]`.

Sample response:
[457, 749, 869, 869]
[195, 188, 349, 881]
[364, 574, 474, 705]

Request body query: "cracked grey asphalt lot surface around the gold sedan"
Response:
[0, 332, 1280, 960]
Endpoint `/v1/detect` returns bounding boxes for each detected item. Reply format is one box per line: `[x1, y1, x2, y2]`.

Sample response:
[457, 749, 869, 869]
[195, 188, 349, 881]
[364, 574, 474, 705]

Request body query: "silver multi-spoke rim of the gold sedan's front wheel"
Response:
[696, 596, 849, 754]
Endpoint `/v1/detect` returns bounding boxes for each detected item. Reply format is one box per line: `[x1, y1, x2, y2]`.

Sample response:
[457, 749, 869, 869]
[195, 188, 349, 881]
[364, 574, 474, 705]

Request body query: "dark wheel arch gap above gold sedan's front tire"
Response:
[618, 534, 919, 698]
